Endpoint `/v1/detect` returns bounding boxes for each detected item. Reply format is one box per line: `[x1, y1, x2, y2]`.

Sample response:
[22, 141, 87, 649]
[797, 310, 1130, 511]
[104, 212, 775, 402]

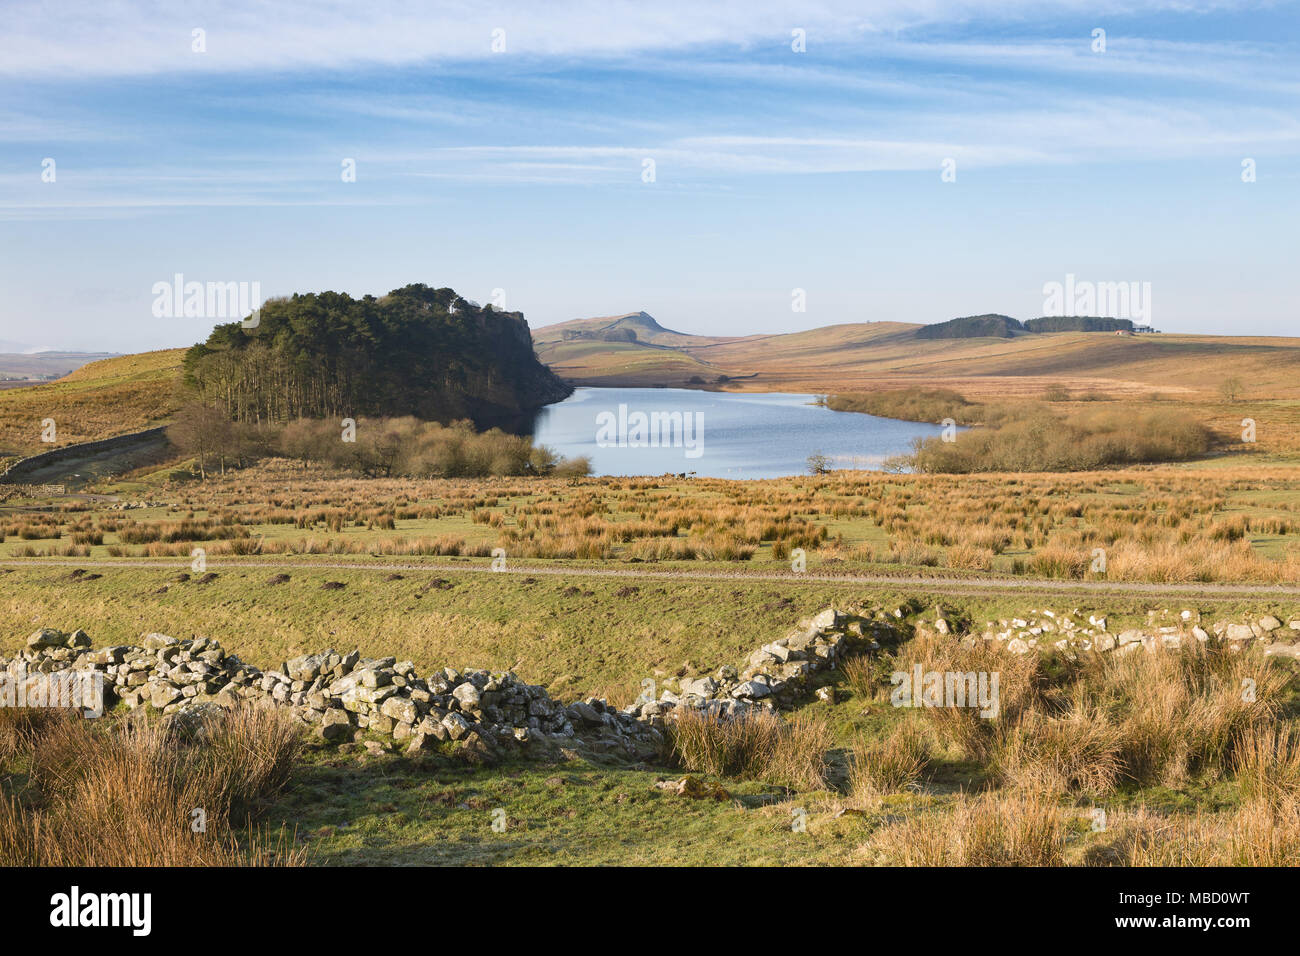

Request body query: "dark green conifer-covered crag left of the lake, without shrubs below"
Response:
[185, 285, 572, 427]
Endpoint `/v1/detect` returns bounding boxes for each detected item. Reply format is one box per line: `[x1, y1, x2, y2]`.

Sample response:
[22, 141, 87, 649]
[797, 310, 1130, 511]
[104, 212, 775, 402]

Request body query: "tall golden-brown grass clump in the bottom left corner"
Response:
[0, 709, 306, 866]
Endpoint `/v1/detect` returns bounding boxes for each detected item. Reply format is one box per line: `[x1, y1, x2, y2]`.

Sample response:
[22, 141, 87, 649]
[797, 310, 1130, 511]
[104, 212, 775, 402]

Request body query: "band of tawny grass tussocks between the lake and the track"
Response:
[12, 447, 1300, 583]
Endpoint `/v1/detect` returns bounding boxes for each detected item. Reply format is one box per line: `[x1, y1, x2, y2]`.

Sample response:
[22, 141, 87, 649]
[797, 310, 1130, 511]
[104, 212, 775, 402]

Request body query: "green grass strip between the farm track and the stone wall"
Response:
[0, 559, 1300, 700]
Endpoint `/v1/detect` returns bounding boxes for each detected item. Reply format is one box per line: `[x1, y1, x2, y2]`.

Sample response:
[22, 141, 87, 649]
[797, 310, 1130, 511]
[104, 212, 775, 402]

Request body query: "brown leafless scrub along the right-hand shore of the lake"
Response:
[826, 388, 1214, 475]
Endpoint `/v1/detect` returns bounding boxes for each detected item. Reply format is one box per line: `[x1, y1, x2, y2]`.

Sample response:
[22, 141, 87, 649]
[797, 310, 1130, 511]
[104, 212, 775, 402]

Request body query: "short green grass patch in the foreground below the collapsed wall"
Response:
[270, 753, 865, 866]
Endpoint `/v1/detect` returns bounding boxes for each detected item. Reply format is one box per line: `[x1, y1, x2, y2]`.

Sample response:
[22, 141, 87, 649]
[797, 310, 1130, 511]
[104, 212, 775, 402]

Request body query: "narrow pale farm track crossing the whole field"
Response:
[0, 558, 1300, 601]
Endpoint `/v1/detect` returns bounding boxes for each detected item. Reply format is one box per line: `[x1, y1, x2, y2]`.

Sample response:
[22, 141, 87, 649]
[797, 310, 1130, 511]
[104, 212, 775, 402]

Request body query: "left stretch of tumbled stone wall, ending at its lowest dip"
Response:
[0, 628, 663, 758]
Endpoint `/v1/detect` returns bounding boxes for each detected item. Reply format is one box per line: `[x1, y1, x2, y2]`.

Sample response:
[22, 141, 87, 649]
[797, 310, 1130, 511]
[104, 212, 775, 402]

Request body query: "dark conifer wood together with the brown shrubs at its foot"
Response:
[168, 285, 588, 477]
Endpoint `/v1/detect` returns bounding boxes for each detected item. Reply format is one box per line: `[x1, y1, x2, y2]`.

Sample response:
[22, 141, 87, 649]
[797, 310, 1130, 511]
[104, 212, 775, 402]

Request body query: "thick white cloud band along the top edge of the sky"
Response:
[0, 0, 1258, 79]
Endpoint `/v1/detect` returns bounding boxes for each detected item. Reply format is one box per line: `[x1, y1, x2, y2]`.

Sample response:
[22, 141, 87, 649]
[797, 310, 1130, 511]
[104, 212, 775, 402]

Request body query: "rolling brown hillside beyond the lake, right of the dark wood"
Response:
[533, 312, 1300, 398]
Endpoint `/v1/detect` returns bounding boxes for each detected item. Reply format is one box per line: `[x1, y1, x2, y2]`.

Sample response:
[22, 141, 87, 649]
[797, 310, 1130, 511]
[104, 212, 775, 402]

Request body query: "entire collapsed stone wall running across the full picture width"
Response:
[0, 602, 1300, 760]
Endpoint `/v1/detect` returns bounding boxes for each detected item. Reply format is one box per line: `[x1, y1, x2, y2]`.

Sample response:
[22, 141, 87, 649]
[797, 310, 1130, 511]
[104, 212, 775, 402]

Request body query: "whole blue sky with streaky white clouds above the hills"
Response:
[0, 0, 1300, 352]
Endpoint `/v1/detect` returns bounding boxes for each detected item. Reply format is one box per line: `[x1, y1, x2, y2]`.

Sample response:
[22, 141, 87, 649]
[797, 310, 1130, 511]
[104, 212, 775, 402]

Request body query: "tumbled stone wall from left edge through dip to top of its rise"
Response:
[0, 609, 879, 760]
